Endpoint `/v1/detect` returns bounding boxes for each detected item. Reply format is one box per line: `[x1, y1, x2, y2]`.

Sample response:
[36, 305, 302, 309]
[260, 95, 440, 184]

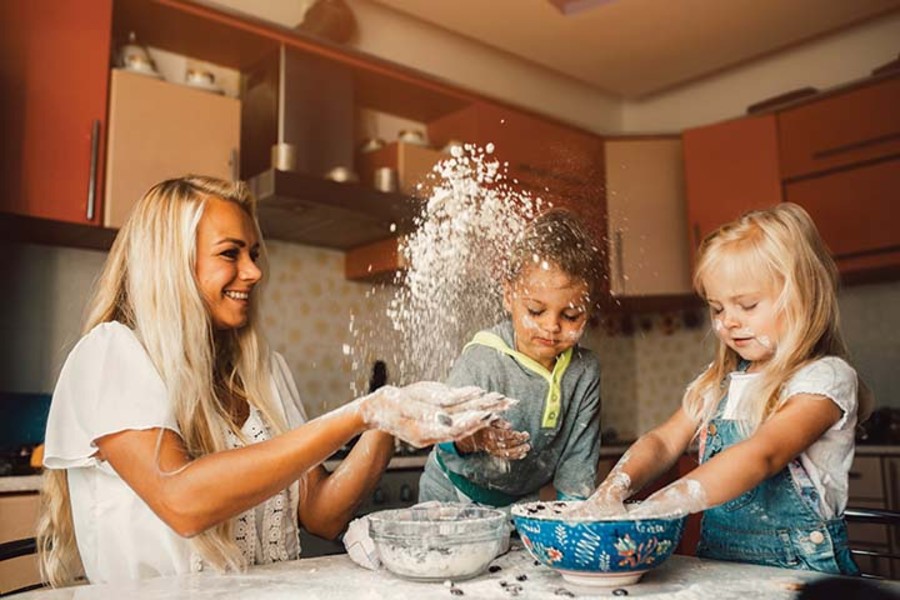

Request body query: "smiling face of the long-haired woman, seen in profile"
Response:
[196, 198, 262, 329]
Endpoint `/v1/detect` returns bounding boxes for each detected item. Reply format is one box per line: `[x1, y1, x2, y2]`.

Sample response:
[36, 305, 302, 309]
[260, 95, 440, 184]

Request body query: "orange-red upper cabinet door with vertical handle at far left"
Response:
[0, 0, 112, 224]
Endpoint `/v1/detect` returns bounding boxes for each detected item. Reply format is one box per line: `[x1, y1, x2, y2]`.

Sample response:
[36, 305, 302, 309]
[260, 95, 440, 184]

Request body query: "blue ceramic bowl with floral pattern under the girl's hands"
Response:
[512, 502, 686, 586]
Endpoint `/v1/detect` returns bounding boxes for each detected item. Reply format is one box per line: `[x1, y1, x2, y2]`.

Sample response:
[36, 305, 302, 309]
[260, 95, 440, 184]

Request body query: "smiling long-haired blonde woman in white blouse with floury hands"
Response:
[38, 176, 510, 585]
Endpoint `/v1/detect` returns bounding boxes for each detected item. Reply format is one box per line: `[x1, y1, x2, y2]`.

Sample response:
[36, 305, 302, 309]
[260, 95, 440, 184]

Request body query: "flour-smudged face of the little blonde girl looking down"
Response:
[703, 263, 783, 370]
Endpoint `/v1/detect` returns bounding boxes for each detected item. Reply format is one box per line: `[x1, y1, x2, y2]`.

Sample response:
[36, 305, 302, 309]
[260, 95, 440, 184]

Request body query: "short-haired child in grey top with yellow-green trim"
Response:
[419, 210, 600, 507]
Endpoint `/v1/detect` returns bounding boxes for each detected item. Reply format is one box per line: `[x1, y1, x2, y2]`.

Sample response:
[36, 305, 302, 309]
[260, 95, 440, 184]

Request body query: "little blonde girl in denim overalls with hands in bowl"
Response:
[576, 203, 871, 574]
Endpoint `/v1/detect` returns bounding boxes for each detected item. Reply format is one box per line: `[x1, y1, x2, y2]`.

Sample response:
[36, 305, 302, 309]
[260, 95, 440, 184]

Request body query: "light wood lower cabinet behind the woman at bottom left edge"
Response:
[0, 493, 41, 595]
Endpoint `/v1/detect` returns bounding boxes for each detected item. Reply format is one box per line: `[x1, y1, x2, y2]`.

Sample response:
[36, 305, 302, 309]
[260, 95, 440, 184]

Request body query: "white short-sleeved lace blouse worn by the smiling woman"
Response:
[44, 322, 306, 583]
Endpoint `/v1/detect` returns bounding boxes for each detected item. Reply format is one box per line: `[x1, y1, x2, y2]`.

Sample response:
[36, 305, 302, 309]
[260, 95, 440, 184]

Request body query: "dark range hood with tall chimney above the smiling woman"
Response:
[241, 46, 418, 249]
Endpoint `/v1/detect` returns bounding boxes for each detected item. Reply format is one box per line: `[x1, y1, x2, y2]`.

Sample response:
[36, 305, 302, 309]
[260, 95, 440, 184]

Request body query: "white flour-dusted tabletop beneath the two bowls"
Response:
[16, 543, 900, 600]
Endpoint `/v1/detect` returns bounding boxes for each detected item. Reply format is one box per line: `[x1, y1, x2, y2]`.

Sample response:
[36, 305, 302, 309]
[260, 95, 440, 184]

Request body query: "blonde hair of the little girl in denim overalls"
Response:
[683, 202, 872, 434]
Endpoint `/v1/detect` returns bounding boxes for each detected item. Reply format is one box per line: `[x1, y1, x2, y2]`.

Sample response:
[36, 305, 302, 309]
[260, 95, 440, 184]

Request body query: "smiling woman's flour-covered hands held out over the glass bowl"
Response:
[357, 381, 517, 447]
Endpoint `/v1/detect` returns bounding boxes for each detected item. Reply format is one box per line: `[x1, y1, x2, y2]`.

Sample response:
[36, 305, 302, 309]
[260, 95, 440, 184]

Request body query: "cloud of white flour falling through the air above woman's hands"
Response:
[345, 144, 550, 394]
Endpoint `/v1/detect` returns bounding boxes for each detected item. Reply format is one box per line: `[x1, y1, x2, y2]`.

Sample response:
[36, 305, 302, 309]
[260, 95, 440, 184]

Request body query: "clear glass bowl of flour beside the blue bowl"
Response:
[368, 503, 509, 581]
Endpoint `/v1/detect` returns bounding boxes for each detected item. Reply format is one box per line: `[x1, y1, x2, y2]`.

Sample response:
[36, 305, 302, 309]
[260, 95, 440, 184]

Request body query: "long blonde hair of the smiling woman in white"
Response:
[38, 175, 287, 586]
